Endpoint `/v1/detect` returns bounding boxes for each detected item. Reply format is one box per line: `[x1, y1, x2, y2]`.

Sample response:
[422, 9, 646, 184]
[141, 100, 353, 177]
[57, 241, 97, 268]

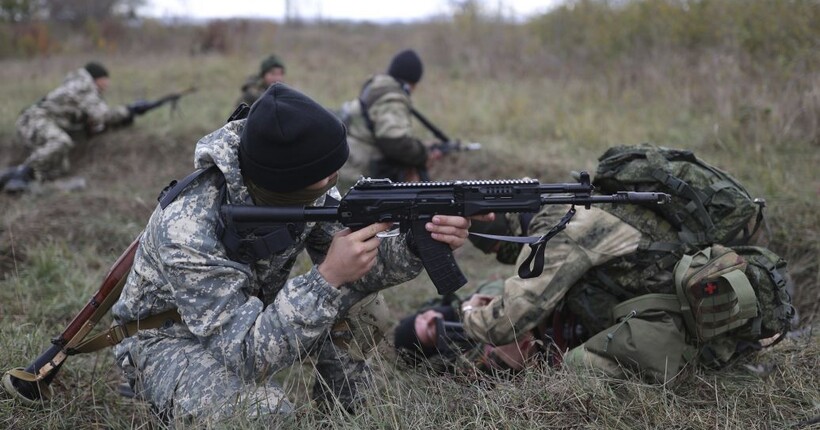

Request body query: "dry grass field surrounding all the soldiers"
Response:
[0, 9, 820, 429]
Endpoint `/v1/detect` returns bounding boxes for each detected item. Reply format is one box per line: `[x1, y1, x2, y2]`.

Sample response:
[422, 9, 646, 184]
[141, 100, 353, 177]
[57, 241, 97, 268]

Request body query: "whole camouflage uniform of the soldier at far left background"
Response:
[17, 68, 133, 180]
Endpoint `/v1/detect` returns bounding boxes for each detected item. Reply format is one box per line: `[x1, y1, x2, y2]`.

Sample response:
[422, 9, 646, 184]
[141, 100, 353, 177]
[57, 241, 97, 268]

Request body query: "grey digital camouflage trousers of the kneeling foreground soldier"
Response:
[114, 293, 389, 419]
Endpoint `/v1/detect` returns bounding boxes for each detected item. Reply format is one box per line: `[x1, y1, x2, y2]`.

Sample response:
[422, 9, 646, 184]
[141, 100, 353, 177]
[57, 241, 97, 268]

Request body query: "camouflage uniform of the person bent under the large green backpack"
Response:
[464, 205, 700, 380]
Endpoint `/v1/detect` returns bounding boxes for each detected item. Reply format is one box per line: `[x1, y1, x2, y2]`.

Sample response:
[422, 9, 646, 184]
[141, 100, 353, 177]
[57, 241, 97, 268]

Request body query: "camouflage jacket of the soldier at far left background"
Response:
[21, 68, 131, 133]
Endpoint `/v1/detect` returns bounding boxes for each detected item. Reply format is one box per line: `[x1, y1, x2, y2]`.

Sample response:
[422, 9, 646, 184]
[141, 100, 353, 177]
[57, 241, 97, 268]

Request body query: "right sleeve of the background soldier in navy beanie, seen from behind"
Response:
[368, 93, 427, 167]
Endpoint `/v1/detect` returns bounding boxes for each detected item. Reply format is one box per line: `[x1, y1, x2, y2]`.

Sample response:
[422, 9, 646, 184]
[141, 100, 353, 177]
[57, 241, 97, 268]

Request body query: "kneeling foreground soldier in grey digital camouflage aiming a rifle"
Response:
[112, 83, 480, 422]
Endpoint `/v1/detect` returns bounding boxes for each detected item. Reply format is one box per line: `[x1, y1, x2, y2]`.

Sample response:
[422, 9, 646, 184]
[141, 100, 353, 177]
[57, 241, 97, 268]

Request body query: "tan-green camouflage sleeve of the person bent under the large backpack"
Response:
[464, 205, 641, 345]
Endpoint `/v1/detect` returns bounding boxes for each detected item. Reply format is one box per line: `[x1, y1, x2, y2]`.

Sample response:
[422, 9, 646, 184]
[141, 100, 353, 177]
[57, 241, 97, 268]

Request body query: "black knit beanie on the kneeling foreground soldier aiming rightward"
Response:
[239, 83, 349, 193]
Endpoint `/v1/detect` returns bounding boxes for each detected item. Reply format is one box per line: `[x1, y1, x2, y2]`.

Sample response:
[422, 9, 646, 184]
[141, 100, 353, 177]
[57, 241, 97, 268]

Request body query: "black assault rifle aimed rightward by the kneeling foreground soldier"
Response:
[221, 172, 670, 295]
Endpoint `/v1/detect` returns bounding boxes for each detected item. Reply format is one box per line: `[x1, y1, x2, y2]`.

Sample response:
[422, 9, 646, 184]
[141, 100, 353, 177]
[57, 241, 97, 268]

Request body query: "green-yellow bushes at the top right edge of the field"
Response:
[530, 0, 820, 65]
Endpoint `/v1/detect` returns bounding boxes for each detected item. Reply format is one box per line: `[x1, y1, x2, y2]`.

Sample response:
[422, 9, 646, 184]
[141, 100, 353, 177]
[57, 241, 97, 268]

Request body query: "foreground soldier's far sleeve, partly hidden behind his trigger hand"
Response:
[307, 223, 422, 293]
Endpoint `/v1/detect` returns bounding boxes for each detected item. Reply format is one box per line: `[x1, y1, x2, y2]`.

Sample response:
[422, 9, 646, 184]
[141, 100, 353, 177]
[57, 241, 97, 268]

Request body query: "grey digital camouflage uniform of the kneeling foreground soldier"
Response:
[113, 120, 421, 416]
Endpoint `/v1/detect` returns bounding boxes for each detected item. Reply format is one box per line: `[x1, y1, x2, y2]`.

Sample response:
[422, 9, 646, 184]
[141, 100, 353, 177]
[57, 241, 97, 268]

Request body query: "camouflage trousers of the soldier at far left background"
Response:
[17, 111, 74, 180]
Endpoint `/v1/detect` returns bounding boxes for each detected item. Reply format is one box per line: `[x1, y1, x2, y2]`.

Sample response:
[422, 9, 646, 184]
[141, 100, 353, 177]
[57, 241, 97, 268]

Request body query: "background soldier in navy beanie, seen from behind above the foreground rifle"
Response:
[342, 49, 442, 182]
